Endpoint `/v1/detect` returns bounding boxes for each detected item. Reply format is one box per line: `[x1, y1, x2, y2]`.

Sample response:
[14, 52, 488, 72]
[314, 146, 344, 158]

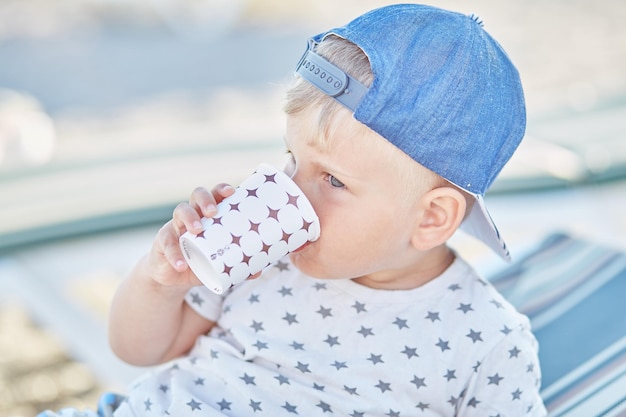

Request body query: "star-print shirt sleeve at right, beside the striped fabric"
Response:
[457, 325, 547, 417]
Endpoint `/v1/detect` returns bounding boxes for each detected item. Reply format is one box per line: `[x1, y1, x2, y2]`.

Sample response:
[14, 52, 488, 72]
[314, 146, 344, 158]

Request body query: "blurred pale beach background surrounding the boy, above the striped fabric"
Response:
[0, 0, 626, 417]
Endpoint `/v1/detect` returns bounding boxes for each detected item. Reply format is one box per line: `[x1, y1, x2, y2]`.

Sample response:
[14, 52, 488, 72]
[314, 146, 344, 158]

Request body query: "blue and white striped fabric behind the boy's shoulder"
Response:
[489, 234, 626, 417]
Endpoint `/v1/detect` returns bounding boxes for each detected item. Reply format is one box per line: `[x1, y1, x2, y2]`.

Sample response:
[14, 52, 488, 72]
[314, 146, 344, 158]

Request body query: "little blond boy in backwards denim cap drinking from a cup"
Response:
[41, 5, 545, 417]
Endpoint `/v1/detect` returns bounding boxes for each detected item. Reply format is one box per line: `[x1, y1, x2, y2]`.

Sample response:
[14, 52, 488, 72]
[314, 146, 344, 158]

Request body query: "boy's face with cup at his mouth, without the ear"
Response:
[285, 109, 426, 288]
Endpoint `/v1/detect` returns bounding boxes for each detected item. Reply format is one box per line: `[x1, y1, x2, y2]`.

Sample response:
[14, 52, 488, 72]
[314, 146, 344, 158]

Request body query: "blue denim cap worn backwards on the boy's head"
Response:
[296, 4, 526, 260]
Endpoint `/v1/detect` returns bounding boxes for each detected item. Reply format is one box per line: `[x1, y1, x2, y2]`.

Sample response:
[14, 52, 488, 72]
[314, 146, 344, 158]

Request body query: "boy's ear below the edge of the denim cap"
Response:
[411, 186, 467, 251]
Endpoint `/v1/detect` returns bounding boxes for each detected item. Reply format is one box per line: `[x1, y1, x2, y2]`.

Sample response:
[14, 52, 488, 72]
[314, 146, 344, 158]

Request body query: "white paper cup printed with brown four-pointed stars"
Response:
[180, 164, 320, 294]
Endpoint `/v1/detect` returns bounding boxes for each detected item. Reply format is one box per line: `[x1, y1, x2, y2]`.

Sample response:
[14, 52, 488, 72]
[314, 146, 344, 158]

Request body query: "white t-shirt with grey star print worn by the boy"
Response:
[115, 258, 546, 417]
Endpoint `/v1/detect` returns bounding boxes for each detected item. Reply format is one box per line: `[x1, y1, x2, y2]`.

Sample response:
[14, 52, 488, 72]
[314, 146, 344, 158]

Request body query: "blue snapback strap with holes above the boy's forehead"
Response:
[296, 39, 368, 112]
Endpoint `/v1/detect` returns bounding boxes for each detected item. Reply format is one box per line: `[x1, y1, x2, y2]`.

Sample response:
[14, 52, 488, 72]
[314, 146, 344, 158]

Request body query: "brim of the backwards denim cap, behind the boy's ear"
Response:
[461, 194, 511, 261]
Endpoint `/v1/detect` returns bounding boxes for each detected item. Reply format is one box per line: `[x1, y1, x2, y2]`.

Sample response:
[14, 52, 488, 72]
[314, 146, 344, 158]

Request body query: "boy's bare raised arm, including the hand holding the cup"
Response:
[109, 184, 234, 366]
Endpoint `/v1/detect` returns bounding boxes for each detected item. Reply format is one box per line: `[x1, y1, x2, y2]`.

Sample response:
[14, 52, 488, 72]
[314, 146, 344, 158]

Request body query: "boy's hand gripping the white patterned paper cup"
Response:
[149, 184, 235, 287]
